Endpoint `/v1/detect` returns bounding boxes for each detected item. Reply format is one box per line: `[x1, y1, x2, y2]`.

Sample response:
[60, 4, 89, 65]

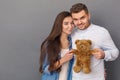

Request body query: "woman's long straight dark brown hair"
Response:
[40, 11, 71, 72]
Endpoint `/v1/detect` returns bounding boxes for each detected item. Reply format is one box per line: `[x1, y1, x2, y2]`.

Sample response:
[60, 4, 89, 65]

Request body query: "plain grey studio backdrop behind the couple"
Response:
[0, 0, 120, 80]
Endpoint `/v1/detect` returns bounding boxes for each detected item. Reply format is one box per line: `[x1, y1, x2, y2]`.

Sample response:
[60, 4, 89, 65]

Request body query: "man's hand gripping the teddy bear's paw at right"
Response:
[92, 48, 105, 59]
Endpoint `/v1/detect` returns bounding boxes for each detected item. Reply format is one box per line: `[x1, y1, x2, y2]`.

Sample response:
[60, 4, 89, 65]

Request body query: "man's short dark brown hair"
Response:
[70, 3, 88, 14]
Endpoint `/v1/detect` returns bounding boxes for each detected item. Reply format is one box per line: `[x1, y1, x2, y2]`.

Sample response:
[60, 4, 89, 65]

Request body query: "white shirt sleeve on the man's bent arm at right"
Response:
[101, 29, 119, 61]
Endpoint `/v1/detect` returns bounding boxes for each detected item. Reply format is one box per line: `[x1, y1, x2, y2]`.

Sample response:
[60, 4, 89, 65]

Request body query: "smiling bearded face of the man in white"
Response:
[72, 10, 90, 30]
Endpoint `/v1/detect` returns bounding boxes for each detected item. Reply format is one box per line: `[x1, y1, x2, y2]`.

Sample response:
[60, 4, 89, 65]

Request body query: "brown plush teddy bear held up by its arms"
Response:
[72, 39, 95, 74]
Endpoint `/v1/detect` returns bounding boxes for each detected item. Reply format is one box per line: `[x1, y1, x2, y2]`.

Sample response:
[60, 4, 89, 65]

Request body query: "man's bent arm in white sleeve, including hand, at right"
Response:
[93, 29, 119, 61]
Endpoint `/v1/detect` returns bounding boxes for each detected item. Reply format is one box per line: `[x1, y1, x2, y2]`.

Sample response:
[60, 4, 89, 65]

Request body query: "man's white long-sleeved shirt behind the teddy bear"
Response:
[71, 24, 119, 80]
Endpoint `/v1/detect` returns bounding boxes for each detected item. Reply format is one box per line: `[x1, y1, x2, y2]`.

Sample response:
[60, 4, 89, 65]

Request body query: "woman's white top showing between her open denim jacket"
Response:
[59, 49, 69, 80]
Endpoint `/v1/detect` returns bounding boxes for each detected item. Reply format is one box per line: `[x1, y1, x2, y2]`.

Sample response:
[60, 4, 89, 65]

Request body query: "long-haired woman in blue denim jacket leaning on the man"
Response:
[40, 11, 74, 80]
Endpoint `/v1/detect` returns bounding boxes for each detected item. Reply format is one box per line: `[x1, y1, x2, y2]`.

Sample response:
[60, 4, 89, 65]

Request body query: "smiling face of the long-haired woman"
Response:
[62, 16, 74, 34]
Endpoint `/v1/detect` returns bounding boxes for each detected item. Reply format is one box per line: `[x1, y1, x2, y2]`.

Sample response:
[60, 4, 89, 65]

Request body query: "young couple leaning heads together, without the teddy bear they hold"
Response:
[40, 3, 119, 80]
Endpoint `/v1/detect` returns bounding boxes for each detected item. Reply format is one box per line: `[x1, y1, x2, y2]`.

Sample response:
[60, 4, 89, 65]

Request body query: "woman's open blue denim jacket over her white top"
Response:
[41, 35, 74, 80]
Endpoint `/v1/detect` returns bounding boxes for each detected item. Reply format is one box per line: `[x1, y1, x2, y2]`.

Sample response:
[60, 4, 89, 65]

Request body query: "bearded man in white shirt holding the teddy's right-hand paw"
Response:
[70, 3, 119, 80]
